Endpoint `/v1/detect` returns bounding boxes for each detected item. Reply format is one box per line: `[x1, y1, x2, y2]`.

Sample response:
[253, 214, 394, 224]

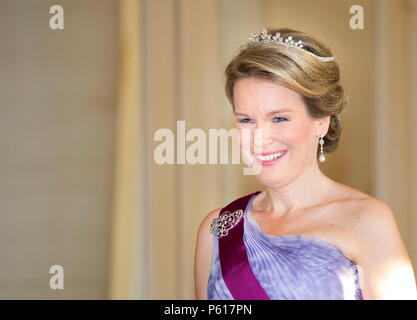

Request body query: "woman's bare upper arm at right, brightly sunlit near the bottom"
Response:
[344, 192, 417, 299]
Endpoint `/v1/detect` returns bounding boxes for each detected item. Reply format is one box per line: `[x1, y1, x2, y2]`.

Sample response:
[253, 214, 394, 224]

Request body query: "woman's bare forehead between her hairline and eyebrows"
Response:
[233, 78, 304, 113]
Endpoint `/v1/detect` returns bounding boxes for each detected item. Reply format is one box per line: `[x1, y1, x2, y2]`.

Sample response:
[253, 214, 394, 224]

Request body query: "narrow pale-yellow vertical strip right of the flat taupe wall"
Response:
[108, 0, 148, 299]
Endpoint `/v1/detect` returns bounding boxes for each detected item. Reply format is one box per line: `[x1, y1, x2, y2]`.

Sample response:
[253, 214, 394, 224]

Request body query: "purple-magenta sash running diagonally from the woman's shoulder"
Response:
[219, 191, 270, 300]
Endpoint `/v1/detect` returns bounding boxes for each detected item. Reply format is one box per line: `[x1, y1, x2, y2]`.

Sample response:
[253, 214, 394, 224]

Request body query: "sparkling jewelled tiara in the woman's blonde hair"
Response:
[247, 28, 334, 62]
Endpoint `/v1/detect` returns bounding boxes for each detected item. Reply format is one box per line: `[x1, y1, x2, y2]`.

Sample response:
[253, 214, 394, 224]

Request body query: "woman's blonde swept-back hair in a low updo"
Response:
[225, 28, 347, 156]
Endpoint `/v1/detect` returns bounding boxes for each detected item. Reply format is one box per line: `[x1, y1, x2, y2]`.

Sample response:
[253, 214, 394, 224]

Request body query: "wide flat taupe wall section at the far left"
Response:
[0, 0, 118, 299]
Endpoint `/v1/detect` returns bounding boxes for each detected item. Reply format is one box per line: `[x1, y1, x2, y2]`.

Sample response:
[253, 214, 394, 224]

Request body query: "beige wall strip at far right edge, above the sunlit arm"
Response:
[373, 0, 417, 271]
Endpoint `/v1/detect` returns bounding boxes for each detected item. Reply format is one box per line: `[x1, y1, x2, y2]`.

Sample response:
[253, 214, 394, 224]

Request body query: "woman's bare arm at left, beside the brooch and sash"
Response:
[194, 208, 221, 299]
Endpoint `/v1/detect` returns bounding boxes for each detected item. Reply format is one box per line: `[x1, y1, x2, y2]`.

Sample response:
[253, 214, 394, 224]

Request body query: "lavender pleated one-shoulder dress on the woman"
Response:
[207, 196, 362, 300]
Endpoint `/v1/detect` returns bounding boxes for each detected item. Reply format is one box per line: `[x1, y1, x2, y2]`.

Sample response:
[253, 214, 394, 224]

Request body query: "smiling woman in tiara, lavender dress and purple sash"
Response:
[195, 29, 416, 299]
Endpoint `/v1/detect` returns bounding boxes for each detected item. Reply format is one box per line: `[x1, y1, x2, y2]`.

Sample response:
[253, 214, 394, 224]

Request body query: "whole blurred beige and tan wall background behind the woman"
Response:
[0, 0, 417, 299]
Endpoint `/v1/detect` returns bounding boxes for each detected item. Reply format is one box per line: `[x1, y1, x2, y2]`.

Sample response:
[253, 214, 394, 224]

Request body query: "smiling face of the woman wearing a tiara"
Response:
[234, 78, 327, 186]
